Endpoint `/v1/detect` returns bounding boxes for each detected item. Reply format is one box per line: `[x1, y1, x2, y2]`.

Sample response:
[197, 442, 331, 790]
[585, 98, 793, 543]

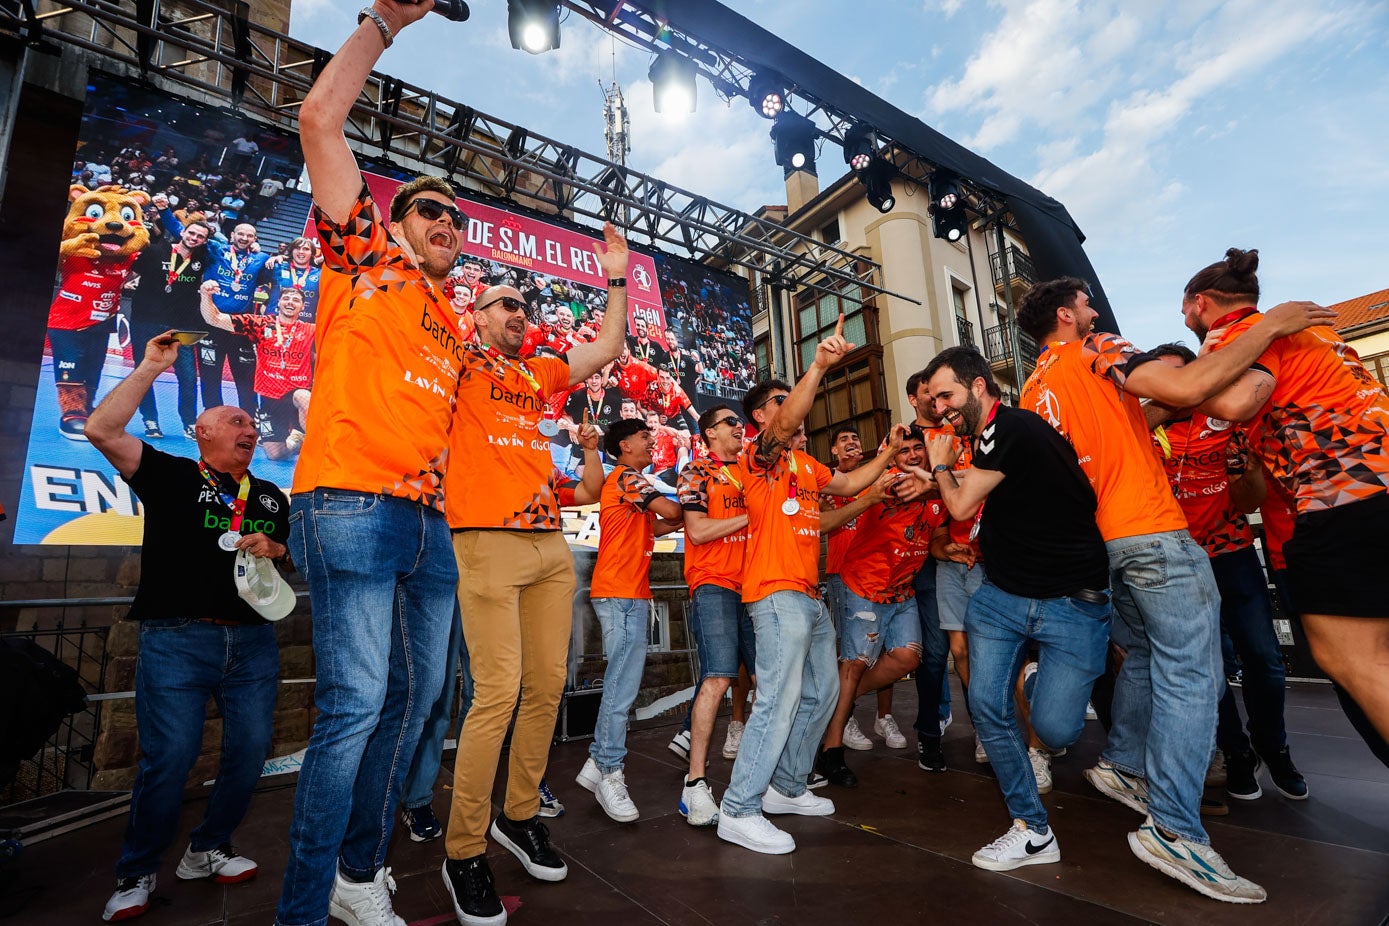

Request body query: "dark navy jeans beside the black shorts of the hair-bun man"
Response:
[1211, 547, 1288, 755]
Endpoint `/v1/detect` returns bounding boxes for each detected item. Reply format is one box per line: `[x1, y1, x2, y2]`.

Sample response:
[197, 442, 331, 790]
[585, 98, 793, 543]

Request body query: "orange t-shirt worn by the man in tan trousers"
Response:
[444, 342, 569, 530]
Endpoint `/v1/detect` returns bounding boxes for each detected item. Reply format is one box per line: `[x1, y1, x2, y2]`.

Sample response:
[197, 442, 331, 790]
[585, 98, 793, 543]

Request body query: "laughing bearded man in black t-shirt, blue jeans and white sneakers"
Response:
[915, 347, 1111, 872]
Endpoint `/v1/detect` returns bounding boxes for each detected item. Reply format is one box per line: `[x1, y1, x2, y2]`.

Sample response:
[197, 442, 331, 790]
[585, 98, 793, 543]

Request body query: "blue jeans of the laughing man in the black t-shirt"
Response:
[965, 580, 1111, 829]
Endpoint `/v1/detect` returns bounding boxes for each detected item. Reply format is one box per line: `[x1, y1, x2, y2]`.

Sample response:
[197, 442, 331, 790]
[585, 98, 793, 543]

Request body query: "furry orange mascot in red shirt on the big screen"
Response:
[49, 186, 150, 440]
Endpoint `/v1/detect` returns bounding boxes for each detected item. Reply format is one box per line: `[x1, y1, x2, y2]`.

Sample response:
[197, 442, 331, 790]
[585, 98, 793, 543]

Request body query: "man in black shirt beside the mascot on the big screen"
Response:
[131, 219, 213, 440]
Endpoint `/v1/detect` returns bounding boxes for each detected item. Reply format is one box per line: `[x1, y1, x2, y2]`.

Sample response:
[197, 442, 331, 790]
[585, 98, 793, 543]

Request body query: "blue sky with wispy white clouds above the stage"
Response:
[290, 0, 1389, 346]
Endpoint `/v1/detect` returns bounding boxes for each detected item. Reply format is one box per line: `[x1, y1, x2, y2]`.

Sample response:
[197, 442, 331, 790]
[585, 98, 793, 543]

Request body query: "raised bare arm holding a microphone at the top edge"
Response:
[299, 0, 433, 224]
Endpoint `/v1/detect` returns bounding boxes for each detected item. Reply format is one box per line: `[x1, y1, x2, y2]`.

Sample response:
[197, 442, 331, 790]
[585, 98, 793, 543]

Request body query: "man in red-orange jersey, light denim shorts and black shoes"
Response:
[815, 426, 946, 787]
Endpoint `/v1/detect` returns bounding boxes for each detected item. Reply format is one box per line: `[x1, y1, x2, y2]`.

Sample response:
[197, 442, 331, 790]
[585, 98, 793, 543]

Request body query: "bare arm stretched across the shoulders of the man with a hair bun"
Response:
[1124, 303, 1336, 408]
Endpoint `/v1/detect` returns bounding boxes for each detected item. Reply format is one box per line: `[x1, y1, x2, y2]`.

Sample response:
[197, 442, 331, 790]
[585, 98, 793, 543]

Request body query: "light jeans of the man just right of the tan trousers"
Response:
[589, 598, 651, 775]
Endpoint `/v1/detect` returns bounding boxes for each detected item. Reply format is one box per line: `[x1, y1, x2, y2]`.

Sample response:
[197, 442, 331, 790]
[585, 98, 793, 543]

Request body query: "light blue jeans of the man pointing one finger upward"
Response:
[720, 591, 839, 816]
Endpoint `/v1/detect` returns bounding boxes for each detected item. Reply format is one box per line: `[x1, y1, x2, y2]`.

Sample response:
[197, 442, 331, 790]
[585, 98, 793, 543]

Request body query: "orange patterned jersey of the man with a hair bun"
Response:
[1201, 312, 1389, 514]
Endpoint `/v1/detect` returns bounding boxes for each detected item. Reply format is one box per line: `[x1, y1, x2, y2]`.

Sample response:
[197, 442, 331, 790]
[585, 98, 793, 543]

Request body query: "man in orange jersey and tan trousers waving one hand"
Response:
[443, 231, 628, 923]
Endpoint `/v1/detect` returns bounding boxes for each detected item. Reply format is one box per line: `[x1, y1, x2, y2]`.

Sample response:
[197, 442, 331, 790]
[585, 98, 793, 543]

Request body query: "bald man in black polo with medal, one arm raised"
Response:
[86, 333, 289, 920]
